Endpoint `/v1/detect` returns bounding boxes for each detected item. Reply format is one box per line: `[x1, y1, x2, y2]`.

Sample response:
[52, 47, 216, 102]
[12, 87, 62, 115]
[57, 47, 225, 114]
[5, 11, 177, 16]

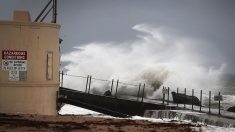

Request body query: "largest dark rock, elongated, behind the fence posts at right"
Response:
[171, 92, 201, 106]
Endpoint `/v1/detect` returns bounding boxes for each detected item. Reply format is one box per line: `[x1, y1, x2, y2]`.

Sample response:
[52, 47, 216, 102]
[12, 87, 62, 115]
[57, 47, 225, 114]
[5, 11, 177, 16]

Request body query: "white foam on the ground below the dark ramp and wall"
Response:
[59, 104, 235, 132]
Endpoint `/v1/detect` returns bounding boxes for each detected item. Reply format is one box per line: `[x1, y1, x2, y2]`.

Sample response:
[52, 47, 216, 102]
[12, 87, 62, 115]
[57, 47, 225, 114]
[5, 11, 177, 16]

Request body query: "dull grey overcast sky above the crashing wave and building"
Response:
[0, 0, 235, 73]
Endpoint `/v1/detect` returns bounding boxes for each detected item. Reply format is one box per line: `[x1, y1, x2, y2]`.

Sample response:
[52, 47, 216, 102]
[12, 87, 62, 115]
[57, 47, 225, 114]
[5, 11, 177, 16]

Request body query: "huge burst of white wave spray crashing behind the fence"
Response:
[61, 24, 226, 96]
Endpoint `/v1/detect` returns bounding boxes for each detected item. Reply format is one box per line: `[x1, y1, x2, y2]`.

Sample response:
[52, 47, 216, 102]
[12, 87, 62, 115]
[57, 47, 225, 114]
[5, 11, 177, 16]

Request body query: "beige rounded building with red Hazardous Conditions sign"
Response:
[0, 11, 60, 115]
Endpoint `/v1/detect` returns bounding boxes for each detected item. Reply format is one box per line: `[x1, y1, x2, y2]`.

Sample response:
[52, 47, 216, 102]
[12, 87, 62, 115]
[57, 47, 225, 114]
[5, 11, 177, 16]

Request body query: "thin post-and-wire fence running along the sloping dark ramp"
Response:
[60, 71, 227, 116]
